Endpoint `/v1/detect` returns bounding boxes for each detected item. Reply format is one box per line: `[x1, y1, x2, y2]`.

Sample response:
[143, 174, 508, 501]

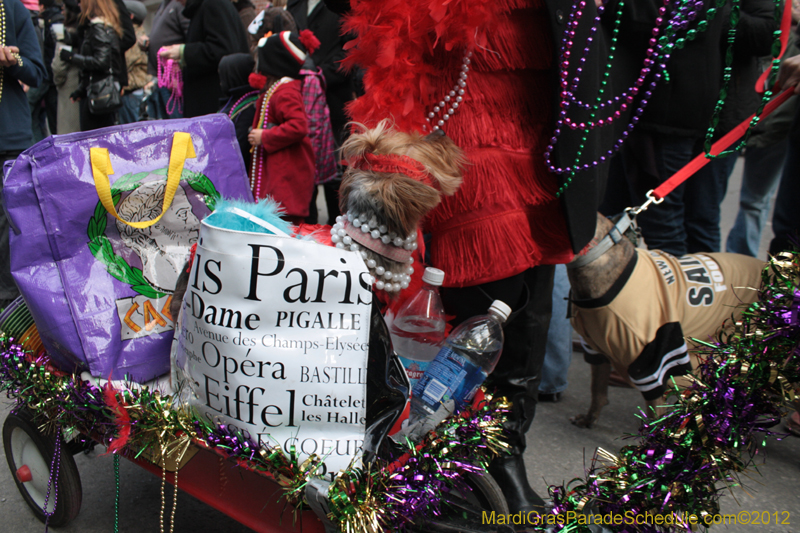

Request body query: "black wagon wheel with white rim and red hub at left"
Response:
[3, 409, 83, 527]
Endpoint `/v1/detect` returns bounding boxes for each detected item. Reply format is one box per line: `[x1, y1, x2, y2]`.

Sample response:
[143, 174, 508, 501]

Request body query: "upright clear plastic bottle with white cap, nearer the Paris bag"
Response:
[389, 267, 445, 388]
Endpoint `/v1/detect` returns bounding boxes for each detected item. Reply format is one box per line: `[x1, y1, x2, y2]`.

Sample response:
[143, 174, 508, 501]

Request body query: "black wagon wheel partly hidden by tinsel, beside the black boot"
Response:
[409, 474, 513, 533]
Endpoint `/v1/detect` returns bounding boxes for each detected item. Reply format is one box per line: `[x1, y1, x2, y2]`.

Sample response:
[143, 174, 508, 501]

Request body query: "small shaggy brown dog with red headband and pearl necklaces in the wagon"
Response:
[331, 120, 466, 293]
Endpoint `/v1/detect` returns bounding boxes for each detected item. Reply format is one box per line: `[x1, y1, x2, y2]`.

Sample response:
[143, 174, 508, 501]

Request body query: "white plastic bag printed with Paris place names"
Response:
[173, 223, 372, 475]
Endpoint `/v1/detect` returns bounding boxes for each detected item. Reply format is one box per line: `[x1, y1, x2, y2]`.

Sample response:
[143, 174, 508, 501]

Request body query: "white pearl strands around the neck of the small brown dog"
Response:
[331, 213, 417, 292]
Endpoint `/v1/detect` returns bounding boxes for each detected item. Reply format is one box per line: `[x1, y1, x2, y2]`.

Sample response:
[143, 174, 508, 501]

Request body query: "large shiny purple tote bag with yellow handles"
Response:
[4, 115, 252, 382]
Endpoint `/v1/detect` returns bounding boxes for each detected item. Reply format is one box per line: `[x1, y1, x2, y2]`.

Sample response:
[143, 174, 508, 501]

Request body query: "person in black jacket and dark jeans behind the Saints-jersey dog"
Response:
[601, 0, 764, 257]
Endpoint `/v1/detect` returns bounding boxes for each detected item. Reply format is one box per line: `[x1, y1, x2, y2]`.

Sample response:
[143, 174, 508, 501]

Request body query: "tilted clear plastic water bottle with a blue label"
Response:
[401, 300, 511, 441]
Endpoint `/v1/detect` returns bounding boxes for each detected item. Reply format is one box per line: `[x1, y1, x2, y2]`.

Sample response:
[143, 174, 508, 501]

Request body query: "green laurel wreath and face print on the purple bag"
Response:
[87, 168, 219, 300]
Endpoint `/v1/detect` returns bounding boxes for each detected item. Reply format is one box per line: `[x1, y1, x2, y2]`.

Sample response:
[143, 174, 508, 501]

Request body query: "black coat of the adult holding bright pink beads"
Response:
[183, 0, 250, 118]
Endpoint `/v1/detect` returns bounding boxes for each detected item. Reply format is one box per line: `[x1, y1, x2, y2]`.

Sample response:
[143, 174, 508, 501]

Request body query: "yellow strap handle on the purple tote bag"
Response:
[89, 131, 197, 229]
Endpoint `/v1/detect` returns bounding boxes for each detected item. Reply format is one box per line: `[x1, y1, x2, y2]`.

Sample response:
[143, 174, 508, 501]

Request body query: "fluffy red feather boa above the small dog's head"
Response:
[343, 0, 496, 131]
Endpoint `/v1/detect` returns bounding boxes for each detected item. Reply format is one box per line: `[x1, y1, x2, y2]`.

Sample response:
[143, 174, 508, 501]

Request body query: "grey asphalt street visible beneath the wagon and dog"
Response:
[0, 156, 800, 533]
